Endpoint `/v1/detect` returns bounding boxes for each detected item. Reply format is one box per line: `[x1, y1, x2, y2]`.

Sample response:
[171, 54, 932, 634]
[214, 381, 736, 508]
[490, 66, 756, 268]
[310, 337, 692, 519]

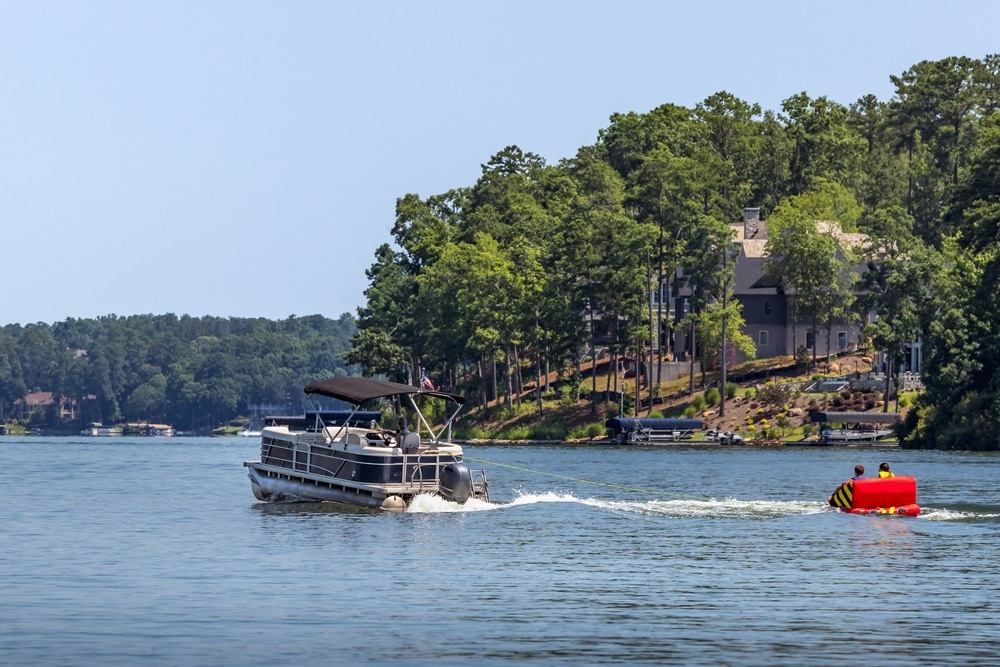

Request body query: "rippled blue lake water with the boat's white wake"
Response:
[0, 436, 1000, 667]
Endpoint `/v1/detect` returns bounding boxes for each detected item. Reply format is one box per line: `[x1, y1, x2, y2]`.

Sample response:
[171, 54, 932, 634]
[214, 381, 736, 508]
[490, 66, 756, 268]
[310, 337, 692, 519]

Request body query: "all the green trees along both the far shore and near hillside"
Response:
[11, 55, 1000, 448]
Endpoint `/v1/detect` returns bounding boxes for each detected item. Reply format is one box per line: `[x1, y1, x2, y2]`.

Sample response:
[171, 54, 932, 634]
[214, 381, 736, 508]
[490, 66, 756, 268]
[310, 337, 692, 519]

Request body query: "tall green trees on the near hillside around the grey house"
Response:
[346, 55, 1000, 449]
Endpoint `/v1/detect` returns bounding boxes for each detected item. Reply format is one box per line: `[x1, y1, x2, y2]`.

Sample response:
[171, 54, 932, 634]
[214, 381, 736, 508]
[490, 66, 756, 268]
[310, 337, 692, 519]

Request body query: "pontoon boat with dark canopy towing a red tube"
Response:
[243, 377, 489, 510]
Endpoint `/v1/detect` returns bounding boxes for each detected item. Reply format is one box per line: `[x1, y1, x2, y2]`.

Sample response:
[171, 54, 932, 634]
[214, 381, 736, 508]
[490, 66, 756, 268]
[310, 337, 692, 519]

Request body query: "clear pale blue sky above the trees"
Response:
[0, 0, 1000, 324]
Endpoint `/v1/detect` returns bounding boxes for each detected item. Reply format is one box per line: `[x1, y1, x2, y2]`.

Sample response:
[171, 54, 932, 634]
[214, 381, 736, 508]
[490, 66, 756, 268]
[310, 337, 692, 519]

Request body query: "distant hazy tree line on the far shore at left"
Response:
[0, 313, 356, 430]
